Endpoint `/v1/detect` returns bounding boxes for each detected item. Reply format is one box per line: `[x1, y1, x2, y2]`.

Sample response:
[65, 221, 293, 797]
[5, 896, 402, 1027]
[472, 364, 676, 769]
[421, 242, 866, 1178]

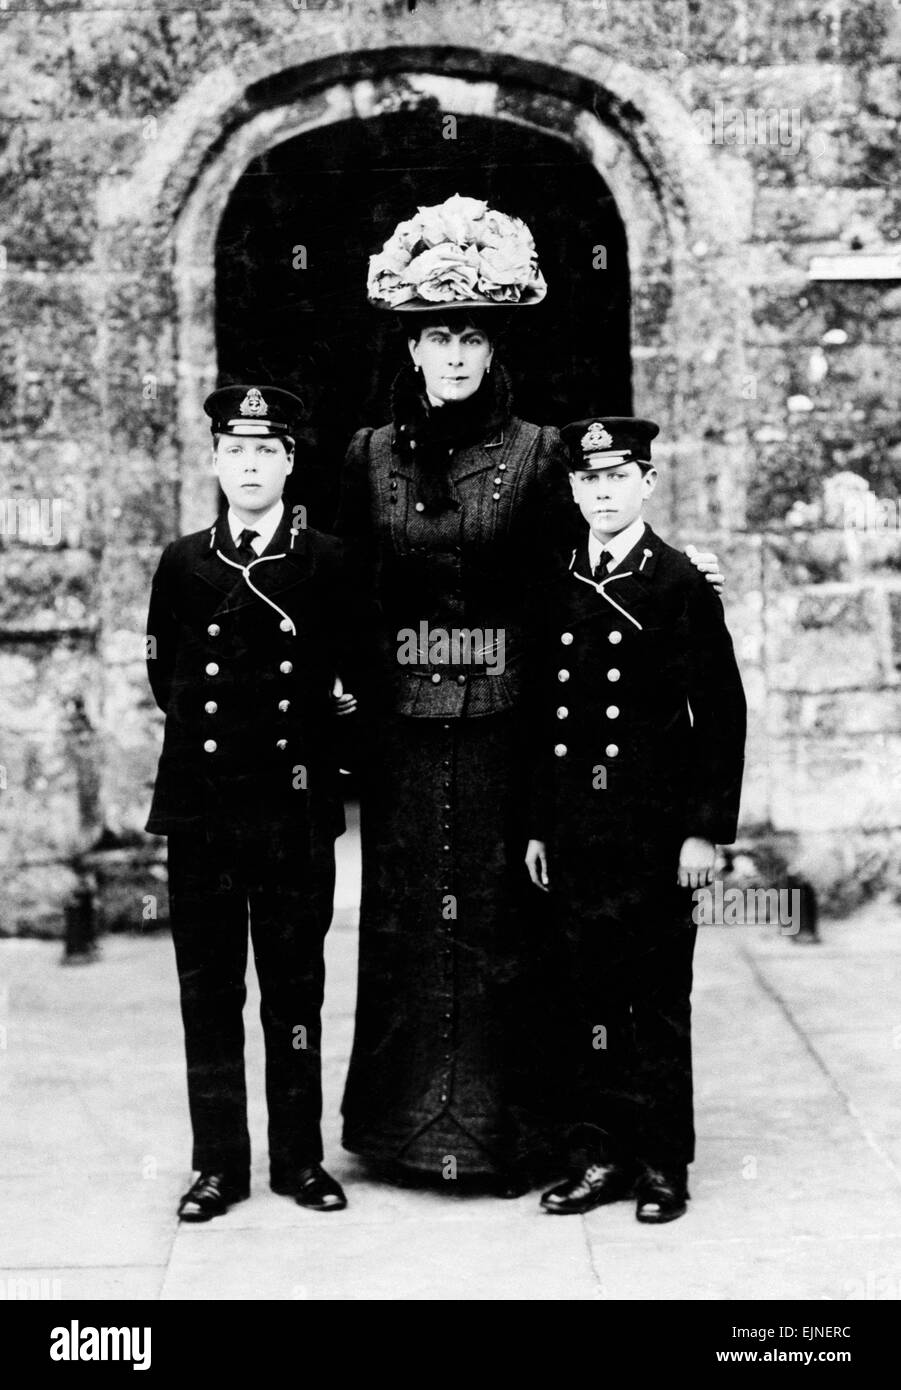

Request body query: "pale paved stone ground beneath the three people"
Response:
[0, 811, 901, 1300]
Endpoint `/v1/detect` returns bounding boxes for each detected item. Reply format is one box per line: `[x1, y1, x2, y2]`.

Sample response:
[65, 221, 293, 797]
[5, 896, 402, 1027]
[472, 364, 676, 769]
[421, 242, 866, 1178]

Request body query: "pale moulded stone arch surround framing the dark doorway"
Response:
[79, 35, 761, 889]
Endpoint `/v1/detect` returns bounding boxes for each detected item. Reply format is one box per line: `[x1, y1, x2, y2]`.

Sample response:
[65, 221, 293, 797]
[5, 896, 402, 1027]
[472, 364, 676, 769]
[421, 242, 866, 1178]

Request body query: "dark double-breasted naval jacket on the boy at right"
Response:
[530, 527, 745, 859]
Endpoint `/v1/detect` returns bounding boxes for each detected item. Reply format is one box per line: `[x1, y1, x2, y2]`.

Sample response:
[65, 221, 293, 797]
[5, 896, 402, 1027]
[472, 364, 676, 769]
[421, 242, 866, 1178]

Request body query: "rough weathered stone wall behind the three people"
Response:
[0, 0, 901, 933]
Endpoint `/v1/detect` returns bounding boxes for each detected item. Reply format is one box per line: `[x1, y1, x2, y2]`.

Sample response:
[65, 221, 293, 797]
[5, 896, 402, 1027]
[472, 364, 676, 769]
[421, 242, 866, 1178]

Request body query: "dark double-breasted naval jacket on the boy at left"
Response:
[147, 513, 363, 835]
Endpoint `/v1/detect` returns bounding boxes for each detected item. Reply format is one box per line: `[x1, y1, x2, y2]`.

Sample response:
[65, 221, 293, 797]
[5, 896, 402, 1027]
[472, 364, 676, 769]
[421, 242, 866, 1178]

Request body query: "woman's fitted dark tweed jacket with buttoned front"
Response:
[335, 373, 565, 719]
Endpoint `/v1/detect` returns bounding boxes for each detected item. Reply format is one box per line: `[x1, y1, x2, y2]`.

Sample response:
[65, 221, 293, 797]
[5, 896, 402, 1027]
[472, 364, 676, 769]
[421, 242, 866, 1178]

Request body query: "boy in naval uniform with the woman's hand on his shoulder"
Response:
[526, 417, 745, 1222]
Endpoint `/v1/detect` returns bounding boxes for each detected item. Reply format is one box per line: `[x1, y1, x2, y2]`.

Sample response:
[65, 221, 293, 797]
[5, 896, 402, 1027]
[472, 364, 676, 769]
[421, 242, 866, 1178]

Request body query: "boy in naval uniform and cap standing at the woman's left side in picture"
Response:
[147, 386, 355, 1222]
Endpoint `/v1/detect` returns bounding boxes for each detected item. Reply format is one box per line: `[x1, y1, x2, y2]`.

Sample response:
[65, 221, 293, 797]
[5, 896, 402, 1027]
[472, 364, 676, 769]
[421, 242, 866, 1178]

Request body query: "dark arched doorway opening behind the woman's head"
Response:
[216, 111, 631, 525]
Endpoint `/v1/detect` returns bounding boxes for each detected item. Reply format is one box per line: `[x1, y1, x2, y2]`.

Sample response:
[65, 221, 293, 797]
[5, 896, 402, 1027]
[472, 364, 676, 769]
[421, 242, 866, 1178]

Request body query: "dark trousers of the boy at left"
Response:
[168, 830, 335, 1182]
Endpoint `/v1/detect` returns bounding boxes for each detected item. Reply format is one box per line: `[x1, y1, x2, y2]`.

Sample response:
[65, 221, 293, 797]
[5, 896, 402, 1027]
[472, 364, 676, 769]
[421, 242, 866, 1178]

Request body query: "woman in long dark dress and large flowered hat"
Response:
[336, 199, 723, 1191]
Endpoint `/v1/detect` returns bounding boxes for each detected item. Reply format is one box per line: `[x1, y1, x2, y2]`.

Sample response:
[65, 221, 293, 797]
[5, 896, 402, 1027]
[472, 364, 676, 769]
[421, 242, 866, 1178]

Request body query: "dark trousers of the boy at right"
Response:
[553, 845, 697, 1168]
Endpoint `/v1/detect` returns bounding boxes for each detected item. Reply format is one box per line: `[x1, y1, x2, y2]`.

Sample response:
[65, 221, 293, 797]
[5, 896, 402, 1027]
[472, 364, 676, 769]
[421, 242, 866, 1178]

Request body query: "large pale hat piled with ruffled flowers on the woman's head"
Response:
[366, 193, 548, 313]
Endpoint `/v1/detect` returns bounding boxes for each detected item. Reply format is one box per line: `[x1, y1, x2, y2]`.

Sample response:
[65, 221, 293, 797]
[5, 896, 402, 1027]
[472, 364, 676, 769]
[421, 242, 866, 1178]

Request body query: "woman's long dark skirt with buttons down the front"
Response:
[343, 713, 556, 1177]
